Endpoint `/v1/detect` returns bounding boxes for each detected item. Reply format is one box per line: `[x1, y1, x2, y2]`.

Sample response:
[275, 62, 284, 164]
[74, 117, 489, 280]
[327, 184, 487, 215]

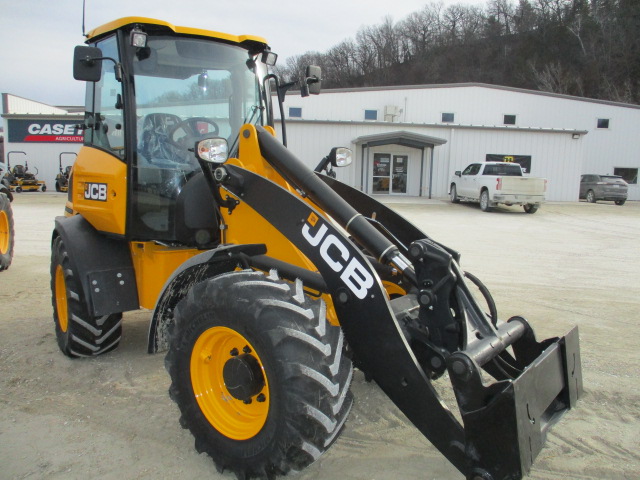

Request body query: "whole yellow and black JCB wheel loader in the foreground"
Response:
[51, 17, 582, 480]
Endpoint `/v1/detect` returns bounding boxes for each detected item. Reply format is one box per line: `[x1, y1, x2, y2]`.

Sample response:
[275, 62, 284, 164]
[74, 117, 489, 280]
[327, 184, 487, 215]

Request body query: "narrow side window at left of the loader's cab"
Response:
[84, 36, 124, 159]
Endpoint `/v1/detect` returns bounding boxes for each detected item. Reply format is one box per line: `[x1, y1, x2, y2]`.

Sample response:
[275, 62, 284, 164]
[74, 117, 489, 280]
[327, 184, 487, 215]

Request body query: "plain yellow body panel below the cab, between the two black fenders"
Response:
[130, 242, 202, 310]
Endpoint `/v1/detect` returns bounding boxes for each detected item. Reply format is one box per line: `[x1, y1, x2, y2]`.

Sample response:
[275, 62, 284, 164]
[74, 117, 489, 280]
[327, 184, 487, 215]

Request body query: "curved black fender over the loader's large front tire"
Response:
[147, 244, 267, 353]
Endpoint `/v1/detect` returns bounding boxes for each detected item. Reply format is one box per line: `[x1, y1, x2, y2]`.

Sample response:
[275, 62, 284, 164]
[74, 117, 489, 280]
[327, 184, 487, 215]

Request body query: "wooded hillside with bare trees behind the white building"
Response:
[277, 0, 640, 103]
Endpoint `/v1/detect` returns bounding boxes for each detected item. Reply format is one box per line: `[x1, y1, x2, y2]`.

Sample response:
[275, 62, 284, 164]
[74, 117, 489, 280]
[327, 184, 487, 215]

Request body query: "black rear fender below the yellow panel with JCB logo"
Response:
[52, 215, 140, 317]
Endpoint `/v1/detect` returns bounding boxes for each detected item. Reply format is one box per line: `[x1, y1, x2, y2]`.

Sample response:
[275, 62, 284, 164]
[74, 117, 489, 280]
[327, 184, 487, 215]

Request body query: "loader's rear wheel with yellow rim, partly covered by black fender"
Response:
[51, 237, 122, 358]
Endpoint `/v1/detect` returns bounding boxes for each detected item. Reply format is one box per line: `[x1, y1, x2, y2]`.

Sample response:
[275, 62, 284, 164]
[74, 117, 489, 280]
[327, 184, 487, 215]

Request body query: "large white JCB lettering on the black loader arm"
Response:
[302, 213, 374, 300]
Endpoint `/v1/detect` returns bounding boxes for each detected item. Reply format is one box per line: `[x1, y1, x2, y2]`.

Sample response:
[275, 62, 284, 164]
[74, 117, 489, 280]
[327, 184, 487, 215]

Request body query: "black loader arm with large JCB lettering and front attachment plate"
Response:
[208, 127, 582, 480]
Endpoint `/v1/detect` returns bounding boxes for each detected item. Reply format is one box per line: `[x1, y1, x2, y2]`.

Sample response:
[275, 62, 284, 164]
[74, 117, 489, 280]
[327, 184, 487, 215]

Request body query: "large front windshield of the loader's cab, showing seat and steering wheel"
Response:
[128, 35, 268, 241]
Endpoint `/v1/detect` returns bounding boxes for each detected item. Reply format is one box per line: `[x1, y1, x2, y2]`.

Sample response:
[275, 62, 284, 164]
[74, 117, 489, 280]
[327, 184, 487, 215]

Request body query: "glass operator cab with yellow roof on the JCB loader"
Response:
[74, 18, 274, 247]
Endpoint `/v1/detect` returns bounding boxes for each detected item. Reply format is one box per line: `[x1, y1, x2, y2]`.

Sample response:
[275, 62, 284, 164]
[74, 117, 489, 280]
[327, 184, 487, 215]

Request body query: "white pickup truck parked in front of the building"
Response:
[449, 162, 547, 213]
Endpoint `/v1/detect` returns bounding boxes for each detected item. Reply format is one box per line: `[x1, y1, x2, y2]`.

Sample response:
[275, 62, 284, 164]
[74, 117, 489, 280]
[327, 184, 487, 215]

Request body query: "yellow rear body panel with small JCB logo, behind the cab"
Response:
[67, 147, 127, 235]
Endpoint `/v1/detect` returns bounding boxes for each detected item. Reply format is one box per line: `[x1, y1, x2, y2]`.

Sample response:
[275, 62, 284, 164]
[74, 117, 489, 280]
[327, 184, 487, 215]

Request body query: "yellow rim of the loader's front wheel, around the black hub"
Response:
[190, 327, 270, 440]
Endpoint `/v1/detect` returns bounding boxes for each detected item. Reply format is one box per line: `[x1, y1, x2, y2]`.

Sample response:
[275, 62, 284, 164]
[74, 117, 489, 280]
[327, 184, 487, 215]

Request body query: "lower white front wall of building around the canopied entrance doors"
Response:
[278, 120, 584, 201]
